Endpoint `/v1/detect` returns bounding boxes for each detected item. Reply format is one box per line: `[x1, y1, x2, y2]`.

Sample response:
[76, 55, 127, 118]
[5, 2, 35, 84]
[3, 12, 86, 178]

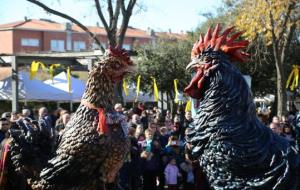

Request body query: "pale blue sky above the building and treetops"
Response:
[0, 0, 222, 33]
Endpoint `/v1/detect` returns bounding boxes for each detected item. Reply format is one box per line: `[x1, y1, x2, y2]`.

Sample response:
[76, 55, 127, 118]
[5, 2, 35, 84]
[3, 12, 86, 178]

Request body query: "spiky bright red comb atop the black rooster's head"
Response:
[191, 24, 249, 62]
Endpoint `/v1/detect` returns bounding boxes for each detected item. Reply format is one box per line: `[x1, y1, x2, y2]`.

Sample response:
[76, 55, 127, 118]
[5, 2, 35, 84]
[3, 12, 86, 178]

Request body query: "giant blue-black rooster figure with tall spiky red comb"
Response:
[185, 25, 299, 190]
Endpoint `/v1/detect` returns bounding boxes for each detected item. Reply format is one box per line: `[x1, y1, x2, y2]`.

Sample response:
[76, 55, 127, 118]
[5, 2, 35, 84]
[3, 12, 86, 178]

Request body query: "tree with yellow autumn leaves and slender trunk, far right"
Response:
[235, 0, 299, 116]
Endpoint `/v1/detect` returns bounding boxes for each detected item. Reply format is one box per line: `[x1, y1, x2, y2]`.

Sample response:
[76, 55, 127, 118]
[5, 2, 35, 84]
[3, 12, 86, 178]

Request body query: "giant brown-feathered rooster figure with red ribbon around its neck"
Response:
[1, 48, 133, 190]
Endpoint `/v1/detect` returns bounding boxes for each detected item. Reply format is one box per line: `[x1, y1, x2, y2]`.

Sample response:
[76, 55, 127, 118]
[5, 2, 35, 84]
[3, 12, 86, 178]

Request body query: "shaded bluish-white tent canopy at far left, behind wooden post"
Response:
[0, 72, 71, 101]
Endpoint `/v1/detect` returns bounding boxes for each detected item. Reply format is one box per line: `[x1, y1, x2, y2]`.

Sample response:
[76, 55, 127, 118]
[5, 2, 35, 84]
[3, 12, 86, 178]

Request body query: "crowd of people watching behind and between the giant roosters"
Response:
[0, 103, 295, 190]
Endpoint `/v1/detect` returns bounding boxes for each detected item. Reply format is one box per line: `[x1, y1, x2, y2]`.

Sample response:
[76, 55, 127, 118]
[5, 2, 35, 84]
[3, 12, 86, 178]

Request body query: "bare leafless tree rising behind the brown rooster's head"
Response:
[27, 0, 137, 102]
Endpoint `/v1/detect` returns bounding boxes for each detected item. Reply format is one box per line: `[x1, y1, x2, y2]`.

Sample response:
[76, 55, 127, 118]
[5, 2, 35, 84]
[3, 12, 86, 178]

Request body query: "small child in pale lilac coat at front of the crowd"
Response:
[164, 158, 181, 190]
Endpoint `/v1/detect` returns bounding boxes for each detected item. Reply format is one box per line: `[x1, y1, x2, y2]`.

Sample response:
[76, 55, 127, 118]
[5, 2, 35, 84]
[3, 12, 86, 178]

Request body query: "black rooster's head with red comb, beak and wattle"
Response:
[184, 24, 249, 99]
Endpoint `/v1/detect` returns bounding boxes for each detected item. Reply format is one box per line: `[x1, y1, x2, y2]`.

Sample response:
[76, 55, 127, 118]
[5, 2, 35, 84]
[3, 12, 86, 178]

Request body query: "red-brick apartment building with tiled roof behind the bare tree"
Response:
[0, 19, 159, 54]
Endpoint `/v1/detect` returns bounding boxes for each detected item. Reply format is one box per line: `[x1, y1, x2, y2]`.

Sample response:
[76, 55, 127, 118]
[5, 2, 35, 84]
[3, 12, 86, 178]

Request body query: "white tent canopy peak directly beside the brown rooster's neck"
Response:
[44, 72, 85, 102]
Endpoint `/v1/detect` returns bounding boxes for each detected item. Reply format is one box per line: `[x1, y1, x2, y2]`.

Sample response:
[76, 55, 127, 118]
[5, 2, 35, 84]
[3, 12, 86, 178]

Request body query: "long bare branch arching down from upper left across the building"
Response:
[27, 0, 105, 53]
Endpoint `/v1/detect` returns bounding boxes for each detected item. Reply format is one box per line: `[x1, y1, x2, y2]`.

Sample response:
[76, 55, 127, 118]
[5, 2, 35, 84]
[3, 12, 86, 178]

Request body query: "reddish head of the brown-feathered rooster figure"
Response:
[97, 47, 135, 83]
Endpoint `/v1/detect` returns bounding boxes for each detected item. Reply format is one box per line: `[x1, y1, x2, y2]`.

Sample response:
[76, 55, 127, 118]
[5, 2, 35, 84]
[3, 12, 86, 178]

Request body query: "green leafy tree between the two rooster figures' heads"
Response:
[131, 39, 192, 108]
